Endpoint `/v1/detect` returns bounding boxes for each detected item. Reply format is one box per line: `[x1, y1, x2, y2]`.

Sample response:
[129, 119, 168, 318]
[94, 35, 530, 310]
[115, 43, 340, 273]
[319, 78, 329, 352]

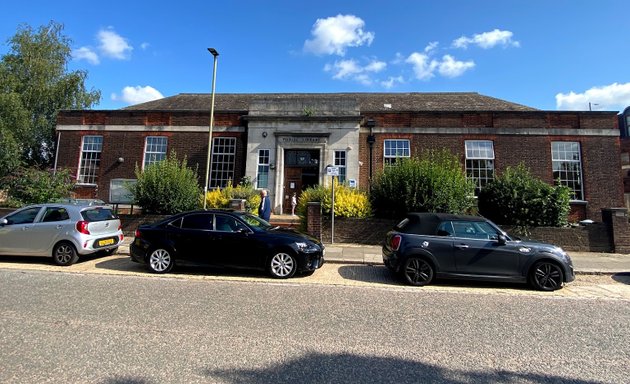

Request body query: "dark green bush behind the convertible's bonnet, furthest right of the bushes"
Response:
[478, 164, 571, 228]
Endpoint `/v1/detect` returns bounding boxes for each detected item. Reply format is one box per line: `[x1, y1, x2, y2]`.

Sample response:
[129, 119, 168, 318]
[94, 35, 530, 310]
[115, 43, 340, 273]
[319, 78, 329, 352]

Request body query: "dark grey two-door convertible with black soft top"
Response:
[383, 213, 575, 291]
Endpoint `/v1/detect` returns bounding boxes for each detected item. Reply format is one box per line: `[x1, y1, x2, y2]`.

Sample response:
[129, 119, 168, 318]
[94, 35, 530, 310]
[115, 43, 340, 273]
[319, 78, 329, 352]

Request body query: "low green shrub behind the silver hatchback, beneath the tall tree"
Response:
[2, 168, 74, 207]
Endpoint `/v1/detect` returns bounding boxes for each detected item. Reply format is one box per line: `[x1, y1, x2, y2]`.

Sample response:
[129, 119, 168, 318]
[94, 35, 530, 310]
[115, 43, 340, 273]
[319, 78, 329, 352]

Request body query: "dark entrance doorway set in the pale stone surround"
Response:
[282, 149, 319, 215]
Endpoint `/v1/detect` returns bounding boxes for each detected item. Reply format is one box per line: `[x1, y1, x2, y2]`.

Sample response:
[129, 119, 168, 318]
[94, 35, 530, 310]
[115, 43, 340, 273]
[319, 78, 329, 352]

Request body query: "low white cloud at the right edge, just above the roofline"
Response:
[556, 83, 630, 111]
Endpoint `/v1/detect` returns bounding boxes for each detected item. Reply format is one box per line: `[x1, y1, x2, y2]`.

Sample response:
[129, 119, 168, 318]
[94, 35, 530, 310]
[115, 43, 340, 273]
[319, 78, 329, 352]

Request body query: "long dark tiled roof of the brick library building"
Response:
[123, 92, 537, 112]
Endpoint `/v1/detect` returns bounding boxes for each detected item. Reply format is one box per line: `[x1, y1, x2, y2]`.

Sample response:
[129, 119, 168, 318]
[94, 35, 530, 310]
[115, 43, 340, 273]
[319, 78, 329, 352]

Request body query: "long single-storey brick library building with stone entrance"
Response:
[55, 93, 624, 221]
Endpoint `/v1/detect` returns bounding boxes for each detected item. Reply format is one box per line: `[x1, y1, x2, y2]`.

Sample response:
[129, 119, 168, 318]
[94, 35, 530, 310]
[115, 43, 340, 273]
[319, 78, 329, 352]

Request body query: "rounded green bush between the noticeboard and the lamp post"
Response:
[132, 152, 202, 215]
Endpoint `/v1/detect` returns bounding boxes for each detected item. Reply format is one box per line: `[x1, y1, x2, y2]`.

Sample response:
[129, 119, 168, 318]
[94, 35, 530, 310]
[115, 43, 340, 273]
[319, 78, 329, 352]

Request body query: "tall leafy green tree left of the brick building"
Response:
[0, 21, 101, 170]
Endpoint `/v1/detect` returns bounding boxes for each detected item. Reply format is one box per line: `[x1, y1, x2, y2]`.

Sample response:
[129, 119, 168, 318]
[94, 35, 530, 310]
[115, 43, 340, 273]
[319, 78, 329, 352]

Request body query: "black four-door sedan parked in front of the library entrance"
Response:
[130, 210, 324, 278]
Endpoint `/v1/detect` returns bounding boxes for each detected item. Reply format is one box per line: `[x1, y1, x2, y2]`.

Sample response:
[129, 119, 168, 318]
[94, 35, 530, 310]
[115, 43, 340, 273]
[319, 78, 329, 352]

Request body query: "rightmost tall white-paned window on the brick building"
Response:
[551, 141, 584, 200]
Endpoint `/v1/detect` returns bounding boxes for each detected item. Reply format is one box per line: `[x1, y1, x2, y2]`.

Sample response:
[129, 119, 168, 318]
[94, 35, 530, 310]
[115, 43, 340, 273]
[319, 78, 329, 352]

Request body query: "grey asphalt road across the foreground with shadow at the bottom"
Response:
[0, 269, 630, 384]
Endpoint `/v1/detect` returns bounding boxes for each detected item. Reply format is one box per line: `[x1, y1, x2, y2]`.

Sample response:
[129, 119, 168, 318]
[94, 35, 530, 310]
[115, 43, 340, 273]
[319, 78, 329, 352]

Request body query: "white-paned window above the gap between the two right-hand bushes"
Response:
[465, 140, 494, 195]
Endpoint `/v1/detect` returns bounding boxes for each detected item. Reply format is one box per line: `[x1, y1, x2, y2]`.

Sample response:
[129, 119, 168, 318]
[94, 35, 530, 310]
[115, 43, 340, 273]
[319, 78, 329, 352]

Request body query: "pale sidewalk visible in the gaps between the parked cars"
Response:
[118, 237, 630, 275]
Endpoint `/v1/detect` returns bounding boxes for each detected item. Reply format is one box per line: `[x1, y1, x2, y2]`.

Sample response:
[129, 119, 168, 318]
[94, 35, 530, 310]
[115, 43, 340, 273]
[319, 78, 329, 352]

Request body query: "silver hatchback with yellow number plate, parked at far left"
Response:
[0, 203, 123, 265]
